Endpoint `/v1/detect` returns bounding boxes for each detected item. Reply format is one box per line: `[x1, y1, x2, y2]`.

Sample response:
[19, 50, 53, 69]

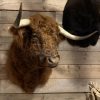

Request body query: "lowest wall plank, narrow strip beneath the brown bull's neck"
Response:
[0, 93, 86, 100]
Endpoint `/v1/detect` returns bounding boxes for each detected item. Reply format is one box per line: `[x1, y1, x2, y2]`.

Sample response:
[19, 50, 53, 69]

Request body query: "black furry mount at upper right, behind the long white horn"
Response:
[62, 0, 100, 47]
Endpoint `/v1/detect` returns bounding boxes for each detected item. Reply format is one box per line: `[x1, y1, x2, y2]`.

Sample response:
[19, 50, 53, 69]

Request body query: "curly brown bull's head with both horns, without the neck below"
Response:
[9, 4, 97, 67]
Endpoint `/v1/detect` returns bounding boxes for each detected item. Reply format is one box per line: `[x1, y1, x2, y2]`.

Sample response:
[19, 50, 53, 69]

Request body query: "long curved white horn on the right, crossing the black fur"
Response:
[58, 26, 98, 40]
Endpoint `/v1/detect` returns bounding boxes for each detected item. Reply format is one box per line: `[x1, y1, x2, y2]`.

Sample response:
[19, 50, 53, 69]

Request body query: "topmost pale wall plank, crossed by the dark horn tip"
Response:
[0, 0, 66, 11]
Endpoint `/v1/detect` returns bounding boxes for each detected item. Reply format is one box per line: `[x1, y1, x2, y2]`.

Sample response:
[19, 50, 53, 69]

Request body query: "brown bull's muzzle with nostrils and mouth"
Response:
[39, 55, 60, 68]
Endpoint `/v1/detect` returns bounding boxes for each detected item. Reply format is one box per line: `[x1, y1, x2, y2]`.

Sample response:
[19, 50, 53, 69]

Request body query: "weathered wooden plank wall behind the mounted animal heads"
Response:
[0, 0, 100, 100]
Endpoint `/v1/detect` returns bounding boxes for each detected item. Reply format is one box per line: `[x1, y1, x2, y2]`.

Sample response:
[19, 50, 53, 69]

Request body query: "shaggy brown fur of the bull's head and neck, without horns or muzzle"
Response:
[6, 14, 59, 92]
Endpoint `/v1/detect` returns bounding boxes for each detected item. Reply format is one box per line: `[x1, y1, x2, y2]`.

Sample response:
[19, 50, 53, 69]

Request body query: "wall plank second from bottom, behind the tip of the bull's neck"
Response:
[0, 79, 100, 93]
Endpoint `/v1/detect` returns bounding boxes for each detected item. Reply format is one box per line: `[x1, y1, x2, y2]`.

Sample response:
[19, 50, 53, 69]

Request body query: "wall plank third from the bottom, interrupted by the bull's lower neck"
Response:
[0, 65, 100, 80]
